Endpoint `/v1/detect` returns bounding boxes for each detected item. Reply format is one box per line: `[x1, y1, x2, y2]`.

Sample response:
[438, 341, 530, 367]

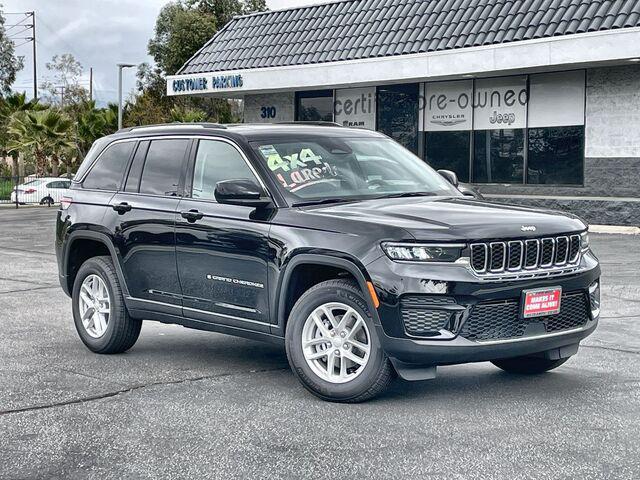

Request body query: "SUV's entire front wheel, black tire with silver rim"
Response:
[286, 280, 395, 403]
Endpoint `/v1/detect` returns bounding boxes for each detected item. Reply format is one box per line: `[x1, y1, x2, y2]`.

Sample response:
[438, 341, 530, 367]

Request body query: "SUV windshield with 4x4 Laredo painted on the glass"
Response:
[252, 137, 460, 205]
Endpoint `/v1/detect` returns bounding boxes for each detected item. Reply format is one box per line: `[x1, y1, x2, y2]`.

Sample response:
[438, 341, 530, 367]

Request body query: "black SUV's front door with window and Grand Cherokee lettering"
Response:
[176, 139, 270, 332]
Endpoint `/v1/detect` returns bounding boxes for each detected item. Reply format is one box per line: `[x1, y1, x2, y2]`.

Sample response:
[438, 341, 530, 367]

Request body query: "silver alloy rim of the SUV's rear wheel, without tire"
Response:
[78, 274, 111, 338]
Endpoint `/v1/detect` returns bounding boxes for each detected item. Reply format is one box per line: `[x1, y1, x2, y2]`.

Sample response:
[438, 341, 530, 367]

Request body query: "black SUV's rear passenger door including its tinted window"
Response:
[105, 138, 192, 315]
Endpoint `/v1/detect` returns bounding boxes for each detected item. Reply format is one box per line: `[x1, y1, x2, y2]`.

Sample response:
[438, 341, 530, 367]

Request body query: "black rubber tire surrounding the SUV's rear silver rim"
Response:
[72, 257, 142, 354]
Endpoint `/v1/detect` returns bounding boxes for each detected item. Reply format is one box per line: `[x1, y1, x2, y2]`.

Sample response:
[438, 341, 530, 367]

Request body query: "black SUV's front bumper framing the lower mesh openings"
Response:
[367, 252, 600, 365]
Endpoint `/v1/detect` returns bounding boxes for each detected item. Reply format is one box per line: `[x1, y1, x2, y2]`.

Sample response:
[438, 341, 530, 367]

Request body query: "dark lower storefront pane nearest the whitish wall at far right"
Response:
[527, 126, 584, 185]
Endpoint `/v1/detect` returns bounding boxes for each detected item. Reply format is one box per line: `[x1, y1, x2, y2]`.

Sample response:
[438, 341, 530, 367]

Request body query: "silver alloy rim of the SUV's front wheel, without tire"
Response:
[302, 302, 371, 383]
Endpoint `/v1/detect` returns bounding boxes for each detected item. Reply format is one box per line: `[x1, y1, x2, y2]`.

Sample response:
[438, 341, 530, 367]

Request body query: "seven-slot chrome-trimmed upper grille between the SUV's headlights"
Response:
[470, 235, 580, 274]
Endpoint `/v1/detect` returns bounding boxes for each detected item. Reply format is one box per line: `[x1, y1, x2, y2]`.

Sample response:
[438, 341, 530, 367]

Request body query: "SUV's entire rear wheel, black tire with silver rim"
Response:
[72, 257, 142, 353]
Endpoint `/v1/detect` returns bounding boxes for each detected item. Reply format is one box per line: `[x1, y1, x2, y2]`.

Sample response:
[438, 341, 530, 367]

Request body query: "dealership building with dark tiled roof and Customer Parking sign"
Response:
[167, 0, 640, 225]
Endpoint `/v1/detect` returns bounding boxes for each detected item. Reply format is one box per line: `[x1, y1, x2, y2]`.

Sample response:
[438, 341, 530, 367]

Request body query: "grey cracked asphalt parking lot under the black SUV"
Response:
[0, 208, 640, 479]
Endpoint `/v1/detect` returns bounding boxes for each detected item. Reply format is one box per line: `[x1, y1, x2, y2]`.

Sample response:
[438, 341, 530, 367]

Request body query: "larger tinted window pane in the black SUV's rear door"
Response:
[140, 139, 191, 196]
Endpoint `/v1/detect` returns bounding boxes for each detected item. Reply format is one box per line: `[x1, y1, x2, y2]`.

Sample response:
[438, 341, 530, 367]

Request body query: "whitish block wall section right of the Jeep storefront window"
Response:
[585, 64, 640, 158]
